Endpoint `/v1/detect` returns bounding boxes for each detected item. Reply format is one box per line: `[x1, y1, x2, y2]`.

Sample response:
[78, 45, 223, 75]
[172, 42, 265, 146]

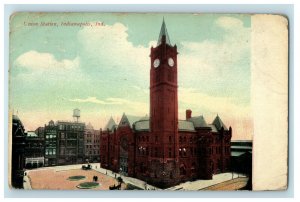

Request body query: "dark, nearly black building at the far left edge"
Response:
[11, 115, 25, 188]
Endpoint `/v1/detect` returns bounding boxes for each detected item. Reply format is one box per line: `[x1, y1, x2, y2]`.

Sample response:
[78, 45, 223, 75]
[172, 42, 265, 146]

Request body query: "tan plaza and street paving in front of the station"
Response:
[24, 163, 248, 190]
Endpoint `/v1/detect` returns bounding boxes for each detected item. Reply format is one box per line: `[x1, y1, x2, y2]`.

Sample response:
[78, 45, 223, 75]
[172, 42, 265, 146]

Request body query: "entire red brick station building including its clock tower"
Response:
[100, 21, 232, 187]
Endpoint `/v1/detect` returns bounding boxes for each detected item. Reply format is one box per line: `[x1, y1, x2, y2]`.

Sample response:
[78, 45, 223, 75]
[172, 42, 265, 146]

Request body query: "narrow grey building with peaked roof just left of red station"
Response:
[84, 123, 100, 163]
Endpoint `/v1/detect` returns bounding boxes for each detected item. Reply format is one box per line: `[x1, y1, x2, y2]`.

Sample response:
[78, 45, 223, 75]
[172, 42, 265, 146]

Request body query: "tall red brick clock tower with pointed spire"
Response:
[150, 20, 179, 185]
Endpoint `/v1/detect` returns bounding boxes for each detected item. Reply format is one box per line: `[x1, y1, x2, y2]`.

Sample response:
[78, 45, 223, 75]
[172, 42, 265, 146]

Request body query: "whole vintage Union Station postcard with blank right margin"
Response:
[8, 12, 288, 191]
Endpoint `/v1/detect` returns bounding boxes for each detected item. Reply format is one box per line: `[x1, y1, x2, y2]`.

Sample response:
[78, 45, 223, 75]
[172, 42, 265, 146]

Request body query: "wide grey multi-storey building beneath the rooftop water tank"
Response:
[56, 121, 85, 165]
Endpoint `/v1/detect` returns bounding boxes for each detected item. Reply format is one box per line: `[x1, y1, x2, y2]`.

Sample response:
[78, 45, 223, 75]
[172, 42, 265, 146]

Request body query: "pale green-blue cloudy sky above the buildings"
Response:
[10, 13, 253, 139]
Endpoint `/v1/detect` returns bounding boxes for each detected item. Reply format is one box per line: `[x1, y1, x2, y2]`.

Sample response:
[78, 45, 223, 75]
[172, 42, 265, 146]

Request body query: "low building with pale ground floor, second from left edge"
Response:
[24, 131, 45, 168]
